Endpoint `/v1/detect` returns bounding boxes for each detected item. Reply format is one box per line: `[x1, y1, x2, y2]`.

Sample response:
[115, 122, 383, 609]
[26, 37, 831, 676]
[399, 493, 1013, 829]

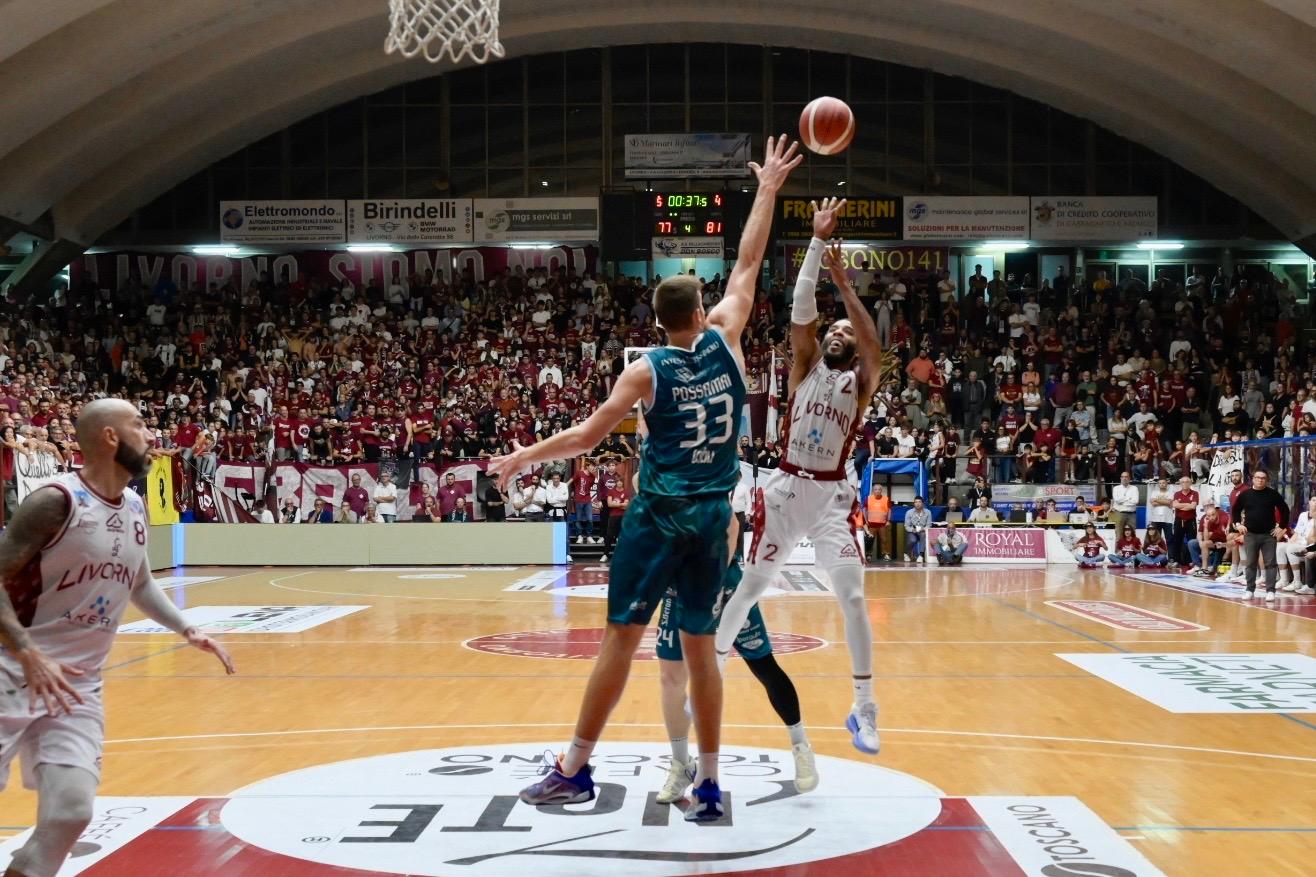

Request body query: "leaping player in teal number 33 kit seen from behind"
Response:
[490, 134, 803, 822]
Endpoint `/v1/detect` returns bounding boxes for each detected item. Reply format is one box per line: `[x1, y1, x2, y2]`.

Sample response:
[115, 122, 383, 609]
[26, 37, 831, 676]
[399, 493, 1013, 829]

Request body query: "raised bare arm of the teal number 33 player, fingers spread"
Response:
[708, 134, 804, 350]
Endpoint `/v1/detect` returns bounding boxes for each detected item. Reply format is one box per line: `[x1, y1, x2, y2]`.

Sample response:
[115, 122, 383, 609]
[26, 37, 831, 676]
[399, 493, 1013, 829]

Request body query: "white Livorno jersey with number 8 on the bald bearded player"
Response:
[0, 473, 150, 682]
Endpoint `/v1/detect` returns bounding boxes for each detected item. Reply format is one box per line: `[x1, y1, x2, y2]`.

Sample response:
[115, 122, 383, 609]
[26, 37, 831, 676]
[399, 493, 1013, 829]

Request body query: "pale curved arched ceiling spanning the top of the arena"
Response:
[0, 0, 1316, 244]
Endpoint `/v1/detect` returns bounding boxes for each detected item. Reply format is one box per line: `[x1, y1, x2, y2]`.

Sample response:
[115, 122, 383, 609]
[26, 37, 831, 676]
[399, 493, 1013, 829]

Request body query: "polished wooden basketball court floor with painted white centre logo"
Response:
[0, 565, 1316, 877]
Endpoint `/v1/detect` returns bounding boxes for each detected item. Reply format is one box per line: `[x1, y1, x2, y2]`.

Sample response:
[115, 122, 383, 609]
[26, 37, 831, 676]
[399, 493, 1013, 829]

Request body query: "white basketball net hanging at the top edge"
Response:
[384, 0, 504, 65]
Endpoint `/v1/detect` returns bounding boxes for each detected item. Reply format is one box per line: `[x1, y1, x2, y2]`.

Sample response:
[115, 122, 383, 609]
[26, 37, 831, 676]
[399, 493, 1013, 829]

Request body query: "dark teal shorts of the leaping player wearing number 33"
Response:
[608, 494, 732, 635]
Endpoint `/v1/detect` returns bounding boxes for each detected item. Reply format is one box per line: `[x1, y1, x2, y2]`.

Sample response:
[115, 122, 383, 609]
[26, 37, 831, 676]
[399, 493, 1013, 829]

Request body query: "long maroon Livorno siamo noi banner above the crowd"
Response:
[70, 246, 599, 290]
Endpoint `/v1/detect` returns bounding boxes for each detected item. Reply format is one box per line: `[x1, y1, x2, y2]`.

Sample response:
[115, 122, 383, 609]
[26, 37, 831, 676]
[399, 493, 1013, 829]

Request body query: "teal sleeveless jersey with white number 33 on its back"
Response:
[640, 328, 745, 496]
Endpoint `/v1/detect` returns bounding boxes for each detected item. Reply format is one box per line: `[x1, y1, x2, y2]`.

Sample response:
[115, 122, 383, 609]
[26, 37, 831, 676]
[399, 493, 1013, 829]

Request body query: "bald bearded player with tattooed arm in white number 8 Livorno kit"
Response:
[0, 399, 233, 877]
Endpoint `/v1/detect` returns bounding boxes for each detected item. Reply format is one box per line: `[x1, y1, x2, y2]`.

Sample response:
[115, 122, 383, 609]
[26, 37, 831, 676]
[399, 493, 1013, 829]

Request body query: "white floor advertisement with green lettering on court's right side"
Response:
[1055, 652, 1316, 714]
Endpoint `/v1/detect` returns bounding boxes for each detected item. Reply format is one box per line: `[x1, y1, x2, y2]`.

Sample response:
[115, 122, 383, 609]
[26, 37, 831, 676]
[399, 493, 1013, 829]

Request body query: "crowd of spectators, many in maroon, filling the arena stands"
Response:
[0, 248, 1316, 531]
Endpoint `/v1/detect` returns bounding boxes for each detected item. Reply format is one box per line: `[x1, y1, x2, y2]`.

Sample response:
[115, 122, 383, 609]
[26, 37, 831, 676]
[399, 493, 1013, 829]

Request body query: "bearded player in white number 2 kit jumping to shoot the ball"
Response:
[715, 198, 882, 755]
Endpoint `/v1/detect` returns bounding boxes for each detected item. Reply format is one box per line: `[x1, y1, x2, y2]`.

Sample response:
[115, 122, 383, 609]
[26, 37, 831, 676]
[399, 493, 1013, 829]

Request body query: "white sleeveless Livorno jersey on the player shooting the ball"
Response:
[784, 358, 859, 473]
